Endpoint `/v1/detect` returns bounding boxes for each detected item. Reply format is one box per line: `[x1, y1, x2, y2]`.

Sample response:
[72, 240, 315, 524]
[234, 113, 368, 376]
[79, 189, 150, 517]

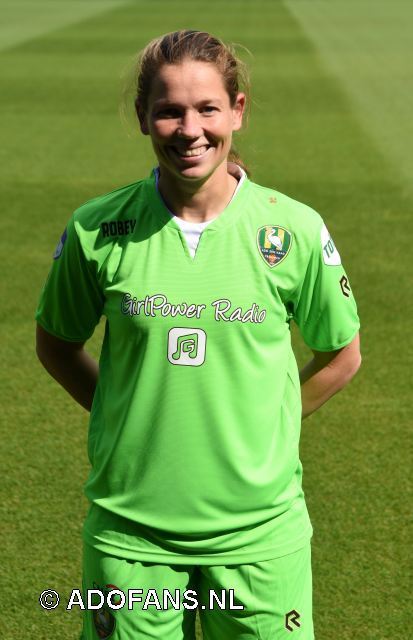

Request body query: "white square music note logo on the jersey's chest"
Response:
[168, 327, 206, 366]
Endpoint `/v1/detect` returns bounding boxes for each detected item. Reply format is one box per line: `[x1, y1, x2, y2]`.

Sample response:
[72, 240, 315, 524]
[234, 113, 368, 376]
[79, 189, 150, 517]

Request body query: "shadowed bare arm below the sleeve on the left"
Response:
[36, 324, 99, 411]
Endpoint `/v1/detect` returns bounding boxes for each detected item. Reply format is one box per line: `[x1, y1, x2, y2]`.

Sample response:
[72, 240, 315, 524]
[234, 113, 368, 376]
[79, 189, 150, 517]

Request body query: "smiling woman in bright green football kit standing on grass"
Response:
[36, 31, 360, 640]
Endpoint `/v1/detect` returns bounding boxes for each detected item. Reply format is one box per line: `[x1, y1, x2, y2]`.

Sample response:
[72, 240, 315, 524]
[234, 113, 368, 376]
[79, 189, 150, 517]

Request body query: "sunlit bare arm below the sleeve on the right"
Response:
[300, 333, 361, 419]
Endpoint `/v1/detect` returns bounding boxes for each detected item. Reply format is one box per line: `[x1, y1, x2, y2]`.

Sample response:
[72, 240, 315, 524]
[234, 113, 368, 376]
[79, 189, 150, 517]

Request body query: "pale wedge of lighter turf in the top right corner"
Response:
[285, 0, 413, 196]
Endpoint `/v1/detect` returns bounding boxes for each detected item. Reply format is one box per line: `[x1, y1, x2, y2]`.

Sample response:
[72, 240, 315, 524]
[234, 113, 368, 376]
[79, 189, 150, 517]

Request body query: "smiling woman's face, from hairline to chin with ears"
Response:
[139, 60, 245, 181]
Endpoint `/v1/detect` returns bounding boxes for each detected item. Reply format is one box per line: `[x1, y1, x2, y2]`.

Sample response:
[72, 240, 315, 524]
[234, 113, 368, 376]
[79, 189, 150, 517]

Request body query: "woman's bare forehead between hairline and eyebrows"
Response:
[149, 60, 229, 104]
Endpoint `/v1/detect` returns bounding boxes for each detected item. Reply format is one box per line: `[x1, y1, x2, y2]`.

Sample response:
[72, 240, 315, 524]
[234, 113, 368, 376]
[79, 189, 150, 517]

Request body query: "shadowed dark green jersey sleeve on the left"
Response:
[36, 217, 104, 342]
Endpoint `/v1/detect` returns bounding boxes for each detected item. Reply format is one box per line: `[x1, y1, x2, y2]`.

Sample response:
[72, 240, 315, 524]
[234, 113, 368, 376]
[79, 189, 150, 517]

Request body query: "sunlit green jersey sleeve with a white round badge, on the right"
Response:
[293, 218, 360, 351]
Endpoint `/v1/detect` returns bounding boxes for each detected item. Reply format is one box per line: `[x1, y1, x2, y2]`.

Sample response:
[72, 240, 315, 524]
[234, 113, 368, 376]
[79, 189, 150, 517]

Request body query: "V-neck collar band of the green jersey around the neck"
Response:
[147, 165, 251, 235]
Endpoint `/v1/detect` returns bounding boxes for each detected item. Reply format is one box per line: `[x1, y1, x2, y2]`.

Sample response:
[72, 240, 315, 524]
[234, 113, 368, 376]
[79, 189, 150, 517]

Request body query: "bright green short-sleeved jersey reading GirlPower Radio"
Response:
[36, 166, 359, 564]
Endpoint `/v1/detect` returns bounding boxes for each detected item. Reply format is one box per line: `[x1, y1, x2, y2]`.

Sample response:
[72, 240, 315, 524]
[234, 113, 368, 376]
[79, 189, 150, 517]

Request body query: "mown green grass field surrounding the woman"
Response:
[0, 0, 413, 640]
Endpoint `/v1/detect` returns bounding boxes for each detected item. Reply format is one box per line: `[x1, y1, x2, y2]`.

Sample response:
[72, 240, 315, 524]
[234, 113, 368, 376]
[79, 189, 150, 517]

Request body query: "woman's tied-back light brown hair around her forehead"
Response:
[124, 30, 250, 176]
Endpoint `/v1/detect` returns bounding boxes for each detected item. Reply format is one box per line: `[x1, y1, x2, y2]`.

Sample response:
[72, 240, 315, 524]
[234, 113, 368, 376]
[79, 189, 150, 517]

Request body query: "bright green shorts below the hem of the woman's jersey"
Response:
[81, 542, 314, 640]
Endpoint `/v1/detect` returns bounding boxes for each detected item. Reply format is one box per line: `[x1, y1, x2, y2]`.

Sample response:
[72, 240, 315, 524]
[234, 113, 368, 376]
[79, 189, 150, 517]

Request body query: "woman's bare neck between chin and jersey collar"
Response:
[158, 162, 238, 222]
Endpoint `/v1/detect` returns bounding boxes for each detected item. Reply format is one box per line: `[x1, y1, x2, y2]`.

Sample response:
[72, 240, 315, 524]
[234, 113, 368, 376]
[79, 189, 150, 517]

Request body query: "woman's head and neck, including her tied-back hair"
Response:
[130, 32, 249, 222]
